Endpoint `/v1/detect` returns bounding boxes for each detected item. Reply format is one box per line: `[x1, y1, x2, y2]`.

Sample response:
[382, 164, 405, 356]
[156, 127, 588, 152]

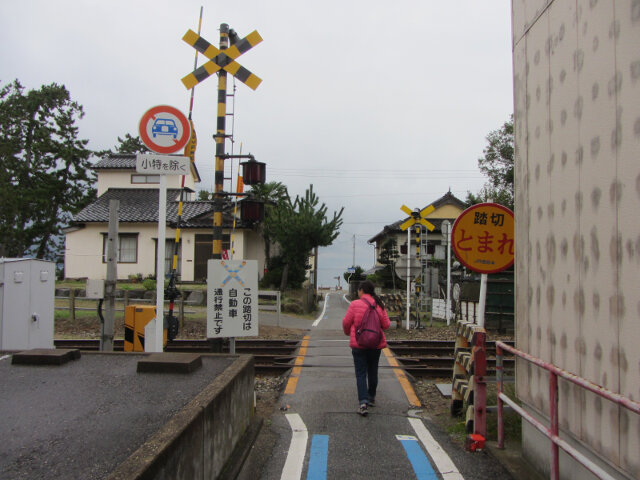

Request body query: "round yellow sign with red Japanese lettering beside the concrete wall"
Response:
[451, 203, 514, 273]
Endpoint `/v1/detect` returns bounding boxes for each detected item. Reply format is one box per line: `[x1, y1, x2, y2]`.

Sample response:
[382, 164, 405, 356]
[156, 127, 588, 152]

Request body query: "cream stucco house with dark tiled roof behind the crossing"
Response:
[64, 155, 265, 281]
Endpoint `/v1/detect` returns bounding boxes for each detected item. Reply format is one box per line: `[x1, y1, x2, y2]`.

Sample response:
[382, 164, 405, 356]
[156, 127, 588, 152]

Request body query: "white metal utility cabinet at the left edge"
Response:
[0, 258, 55, 350]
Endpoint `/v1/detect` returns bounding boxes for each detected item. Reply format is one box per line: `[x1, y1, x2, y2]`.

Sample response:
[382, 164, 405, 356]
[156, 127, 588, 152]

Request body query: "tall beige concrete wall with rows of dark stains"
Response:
[512, 0, 640, 478]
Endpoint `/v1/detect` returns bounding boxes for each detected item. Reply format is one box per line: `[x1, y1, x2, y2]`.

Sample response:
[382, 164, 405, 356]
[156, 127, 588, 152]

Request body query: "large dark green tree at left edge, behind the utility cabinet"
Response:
[0, 80, 95, 259]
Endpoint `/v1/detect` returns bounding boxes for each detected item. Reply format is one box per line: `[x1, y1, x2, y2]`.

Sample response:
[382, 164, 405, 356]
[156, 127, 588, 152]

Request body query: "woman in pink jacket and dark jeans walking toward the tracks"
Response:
[342, 280, 391, 417]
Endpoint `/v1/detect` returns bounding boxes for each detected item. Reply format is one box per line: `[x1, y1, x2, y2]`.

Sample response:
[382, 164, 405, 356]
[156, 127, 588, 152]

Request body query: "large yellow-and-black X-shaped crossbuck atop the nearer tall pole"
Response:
[182, 30, 262, 90]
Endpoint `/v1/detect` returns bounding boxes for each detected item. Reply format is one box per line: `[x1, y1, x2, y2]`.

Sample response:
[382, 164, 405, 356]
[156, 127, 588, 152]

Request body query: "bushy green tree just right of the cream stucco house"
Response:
[264, 185, 344, 290]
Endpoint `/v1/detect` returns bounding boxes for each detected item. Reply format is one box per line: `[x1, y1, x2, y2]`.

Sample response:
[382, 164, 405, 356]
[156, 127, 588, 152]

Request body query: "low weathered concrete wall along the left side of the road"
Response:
[108, 355, 254, 480]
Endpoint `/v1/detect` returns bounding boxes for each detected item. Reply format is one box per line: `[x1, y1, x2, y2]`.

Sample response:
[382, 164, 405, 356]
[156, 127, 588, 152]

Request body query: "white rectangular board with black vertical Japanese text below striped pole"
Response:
[207, 259, 258, 338]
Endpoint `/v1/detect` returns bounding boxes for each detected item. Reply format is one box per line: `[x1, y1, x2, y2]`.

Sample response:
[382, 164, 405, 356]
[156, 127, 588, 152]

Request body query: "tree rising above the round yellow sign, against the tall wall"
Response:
[466, 115, 515, 210]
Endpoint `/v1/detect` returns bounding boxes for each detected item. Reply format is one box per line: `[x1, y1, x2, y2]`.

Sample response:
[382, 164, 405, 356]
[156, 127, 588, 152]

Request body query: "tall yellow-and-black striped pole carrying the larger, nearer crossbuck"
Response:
[212, 23, 229, 260]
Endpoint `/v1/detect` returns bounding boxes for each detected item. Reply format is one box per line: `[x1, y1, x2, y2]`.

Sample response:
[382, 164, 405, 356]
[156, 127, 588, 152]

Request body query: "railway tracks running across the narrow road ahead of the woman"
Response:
[54, 339, 514, 378]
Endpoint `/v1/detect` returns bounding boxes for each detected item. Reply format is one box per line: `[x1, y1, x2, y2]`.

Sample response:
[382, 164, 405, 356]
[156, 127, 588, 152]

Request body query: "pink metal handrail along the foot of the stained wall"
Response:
[496, 342, 640, 480]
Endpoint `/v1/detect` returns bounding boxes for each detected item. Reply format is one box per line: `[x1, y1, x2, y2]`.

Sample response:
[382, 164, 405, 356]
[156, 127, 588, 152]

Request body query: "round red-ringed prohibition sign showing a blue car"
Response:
[139, 105, 191, 153]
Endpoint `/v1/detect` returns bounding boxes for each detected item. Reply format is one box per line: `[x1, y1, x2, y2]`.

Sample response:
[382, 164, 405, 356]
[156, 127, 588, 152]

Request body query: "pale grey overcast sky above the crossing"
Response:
[0, 0, 513, 286]
